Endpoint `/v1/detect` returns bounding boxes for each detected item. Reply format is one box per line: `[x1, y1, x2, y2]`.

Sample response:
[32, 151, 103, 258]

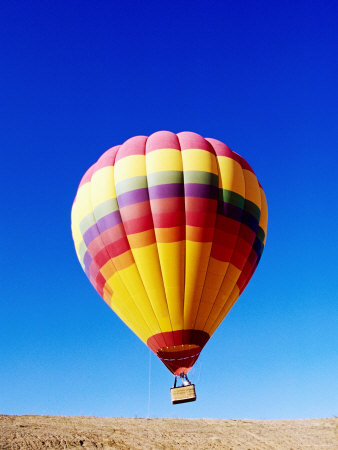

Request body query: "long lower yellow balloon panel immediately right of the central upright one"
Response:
[184, 241, 212, 329]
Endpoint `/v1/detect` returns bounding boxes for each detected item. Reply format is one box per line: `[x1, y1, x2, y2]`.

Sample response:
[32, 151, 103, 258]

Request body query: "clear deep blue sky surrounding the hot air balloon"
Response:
[0, 0, 338, 419]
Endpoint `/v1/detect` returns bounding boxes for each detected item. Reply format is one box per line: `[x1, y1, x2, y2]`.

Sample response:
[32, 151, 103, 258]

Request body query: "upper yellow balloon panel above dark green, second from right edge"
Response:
[217, 156, 245, 197]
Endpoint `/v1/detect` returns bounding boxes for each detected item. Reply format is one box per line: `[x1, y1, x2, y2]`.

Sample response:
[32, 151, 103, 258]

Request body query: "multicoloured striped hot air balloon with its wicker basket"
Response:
[72, 131, 267, 403]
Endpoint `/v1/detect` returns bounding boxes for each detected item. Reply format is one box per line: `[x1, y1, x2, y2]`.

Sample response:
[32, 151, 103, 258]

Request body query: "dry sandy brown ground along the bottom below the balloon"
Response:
[0, 415, 338, 450]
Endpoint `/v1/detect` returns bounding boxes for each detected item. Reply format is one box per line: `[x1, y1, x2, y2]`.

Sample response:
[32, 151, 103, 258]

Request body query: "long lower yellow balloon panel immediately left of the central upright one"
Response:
[132, 244, 172, 332]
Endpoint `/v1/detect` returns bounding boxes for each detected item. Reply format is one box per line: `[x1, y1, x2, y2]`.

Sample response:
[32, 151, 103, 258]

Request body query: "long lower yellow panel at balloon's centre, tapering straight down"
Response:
[155, 243, 185, 330]
